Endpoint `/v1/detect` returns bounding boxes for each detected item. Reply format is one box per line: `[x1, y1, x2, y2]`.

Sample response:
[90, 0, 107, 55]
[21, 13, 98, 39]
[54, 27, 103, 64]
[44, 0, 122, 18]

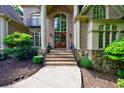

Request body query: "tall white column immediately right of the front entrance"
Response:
[73, 5, 78, 48]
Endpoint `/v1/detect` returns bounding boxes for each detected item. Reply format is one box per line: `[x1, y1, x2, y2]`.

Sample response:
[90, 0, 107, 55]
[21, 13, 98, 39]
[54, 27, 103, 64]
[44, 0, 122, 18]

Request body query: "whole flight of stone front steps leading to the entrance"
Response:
[45, 49, 77, 66]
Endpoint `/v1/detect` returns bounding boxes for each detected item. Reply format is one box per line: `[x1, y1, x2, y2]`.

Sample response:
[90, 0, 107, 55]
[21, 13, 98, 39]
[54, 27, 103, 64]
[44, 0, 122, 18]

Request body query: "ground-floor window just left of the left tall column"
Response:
[32, 32, 41, 47]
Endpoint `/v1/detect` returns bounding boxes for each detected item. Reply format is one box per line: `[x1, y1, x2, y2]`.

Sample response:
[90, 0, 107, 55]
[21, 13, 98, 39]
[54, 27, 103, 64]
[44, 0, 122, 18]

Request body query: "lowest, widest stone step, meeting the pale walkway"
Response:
[45, 61, 77, 66]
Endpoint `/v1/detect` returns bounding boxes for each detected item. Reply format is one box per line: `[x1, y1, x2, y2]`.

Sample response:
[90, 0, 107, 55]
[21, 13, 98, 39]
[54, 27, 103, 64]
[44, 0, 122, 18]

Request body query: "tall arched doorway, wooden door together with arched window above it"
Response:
[54, 13, 67, 48]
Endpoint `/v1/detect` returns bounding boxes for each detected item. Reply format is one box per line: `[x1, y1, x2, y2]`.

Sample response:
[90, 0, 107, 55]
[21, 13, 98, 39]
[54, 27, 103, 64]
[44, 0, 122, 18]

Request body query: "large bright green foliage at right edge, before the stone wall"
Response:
[105, 38, 124, 61]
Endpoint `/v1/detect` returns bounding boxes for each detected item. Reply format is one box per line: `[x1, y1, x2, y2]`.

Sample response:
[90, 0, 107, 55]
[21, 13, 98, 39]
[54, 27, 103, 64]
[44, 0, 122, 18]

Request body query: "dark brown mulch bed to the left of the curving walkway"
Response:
[0, 59, 42, 86]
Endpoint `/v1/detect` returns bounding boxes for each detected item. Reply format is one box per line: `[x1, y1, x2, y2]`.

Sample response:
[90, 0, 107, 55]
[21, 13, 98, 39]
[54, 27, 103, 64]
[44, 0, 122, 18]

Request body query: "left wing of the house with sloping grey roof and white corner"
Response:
[0, 5, 29, 50]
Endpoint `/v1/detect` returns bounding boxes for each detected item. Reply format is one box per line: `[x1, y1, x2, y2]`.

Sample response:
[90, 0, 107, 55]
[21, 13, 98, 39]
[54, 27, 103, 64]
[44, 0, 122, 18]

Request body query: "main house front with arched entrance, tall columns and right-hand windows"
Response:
[22, 5, 124, 56]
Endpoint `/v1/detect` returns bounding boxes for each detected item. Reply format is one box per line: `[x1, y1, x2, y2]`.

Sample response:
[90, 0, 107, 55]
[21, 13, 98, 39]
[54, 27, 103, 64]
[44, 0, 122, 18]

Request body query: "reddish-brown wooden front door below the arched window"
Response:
[54, 32, 66, 48]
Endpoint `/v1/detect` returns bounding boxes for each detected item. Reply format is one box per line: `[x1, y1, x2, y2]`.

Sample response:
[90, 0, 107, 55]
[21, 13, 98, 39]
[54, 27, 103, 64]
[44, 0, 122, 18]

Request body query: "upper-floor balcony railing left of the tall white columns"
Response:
[26, 18, 41, 27]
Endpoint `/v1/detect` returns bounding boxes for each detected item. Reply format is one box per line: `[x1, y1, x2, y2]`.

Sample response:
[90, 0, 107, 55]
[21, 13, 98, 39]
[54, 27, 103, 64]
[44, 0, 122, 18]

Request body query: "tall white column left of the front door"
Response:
[41, 5, 46, 49]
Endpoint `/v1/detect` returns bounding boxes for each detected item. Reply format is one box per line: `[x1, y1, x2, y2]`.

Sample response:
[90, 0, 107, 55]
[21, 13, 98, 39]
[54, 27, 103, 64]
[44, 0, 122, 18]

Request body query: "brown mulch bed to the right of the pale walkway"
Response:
[81, 68, 117, 88]
